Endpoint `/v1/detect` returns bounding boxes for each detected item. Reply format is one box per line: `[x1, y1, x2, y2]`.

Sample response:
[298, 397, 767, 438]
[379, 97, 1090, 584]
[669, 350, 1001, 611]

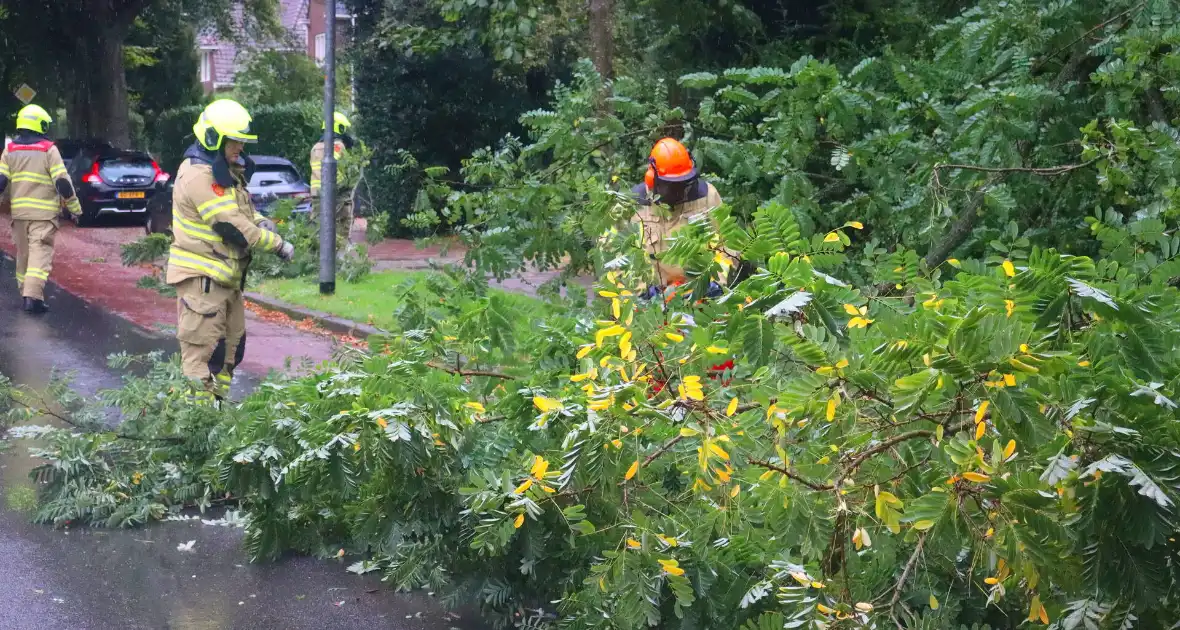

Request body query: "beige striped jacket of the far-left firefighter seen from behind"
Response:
[0, 139, 81, 221]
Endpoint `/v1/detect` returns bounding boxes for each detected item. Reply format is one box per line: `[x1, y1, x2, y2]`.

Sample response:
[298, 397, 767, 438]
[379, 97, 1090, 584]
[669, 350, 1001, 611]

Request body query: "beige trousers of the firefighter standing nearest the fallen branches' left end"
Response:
[176, 277, 245, 398]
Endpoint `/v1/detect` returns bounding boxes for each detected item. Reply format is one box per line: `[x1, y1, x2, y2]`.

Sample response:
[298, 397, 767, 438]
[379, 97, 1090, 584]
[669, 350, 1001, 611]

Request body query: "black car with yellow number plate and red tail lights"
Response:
[66, 143, 170, 227]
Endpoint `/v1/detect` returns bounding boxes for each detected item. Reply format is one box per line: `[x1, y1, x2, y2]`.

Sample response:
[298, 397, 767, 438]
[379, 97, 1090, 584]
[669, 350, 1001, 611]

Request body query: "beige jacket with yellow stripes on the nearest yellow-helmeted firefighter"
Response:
[166, 159, 283, 288]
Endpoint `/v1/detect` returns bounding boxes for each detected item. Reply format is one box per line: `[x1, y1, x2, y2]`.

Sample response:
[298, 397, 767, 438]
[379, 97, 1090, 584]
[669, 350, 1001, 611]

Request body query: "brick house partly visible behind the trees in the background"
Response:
[197, 0, 353, 94]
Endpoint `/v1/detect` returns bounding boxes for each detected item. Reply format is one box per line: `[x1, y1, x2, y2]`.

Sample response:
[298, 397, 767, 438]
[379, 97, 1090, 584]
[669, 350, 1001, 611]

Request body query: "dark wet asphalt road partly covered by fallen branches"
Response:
[0, 258, 479, 630]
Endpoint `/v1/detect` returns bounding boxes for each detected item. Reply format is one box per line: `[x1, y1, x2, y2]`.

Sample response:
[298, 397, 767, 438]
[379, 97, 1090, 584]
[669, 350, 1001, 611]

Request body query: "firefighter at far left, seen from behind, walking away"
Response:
[0, 105, 81, 313]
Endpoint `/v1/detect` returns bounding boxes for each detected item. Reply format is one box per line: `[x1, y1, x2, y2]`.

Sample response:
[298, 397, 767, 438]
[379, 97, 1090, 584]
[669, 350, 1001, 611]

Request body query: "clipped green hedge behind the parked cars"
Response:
[146, 100, 322, 177]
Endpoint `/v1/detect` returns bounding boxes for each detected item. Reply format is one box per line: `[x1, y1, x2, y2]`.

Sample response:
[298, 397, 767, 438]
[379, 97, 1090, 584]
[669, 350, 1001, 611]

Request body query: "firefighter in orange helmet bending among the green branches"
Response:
[632, 138, 721, 297]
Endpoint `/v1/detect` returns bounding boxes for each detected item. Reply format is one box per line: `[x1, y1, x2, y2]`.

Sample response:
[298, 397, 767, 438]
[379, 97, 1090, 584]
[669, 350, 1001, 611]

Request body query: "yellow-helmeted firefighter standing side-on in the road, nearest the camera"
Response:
[166, 99, 295, 400]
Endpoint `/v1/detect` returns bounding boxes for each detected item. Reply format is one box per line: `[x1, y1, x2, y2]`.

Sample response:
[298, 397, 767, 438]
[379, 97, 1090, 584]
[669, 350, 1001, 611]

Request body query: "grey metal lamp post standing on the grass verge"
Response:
[320, 0, 336, 295]
